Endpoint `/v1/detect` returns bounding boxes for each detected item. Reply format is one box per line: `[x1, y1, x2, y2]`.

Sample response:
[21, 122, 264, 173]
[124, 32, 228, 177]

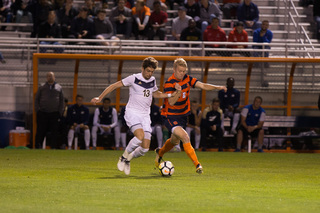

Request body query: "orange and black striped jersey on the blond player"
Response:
[161, 75, 198, 117]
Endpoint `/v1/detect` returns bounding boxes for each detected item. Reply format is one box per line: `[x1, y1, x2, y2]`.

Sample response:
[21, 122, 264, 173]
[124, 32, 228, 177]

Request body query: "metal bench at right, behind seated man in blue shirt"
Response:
[224, 116, 320, 152]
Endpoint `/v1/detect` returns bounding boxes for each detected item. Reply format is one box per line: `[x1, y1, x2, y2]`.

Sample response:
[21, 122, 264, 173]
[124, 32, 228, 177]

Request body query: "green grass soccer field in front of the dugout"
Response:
[0, 150, 320, 213]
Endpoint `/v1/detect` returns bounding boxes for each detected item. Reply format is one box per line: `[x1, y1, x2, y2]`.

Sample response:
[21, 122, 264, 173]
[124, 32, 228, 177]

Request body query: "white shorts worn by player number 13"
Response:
[124, 109, 152, 133]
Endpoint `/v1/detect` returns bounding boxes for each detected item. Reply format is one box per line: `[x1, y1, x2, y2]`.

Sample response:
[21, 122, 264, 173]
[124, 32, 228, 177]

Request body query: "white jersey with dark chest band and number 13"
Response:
[122, 73, 158, 115]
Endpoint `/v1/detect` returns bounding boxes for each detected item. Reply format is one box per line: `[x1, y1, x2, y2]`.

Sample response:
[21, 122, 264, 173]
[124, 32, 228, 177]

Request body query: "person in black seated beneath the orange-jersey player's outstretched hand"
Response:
[201, 98, 223, 152]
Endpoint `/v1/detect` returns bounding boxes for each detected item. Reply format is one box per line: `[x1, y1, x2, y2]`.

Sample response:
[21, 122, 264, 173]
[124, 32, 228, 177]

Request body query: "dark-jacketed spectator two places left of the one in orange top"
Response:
[93, 9, 119, 46]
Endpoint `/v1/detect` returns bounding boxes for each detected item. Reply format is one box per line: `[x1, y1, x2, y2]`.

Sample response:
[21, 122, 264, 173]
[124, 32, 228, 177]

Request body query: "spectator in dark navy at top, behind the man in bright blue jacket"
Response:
[237, 0, 261, 30]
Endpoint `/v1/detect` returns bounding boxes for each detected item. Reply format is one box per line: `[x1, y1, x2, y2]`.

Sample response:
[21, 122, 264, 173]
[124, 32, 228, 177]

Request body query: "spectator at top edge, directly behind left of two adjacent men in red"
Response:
[200, 0, 222, 32]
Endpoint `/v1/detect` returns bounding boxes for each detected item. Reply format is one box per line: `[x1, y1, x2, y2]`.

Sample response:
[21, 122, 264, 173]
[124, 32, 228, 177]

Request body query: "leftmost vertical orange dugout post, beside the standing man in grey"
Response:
[32, 56, 39, 149]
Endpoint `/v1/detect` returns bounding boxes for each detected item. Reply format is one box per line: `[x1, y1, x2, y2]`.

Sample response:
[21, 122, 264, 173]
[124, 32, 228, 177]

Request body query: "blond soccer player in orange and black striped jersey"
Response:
[155, 58, 227, 174]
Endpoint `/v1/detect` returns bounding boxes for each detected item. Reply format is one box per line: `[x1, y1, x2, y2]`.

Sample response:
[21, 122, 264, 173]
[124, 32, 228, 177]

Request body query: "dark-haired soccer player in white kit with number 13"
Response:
[91, 57, 181, 175]
